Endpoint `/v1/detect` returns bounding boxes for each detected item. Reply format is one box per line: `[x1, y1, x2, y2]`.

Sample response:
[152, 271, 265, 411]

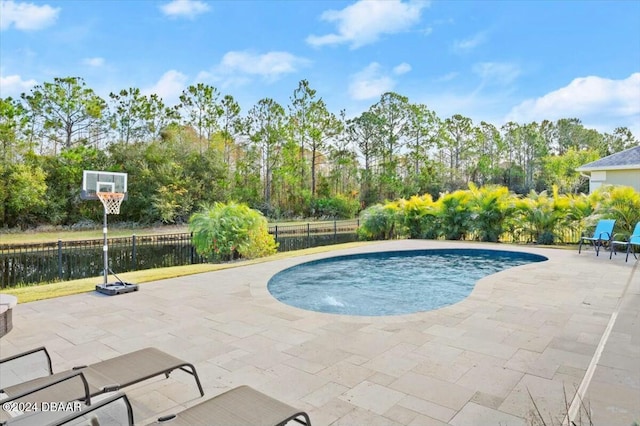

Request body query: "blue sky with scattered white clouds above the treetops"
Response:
[0, 0, 640, 137]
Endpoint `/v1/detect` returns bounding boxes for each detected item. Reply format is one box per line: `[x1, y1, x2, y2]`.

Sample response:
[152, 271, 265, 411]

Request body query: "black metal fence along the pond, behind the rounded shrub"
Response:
[0, 220, 358, 289]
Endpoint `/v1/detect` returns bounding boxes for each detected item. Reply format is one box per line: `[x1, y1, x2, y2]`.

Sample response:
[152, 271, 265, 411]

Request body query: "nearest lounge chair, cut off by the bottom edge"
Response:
[7, 386, 311, 426]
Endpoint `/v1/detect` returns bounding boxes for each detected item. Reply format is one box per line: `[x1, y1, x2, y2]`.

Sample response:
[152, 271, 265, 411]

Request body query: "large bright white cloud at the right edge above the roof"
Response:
[506, 73, 640, 134]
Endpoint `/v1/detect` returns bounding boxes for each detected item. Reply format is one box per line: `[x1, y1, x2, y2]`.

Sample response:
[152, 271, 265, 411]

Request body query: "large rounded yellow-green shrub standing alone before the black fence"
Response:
[189, 202, 277, 260]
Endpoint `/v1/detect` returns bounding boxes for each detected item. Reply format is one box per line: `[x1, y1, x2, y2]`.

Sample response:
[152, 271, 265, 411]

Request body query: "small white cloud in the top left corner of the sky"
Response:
[0, 0, 60, 31]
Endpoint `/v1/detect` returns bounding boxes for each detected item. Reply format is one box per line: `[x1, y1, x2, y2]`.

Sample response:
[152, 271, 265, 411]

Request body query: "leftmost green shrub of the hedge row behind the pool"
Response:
[358, 202, 405, 240]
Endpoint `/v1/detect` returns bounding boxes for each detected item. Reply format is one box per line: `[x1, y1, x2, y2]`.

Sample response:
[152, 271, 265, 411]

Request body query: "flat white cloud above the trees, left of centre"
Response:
[216, 51, 309, 81]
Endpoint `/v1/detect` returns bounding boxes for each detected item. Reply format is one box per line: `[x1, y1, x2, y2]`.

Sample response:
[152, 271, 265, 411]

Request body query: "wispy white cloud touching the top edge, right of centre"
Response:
[307, 0, 429, 49]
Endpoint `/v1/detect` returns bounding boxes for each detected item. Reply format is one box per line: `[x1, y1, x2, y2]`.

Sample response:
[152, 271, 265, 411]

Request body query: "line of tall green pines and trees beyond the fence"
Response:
[0, 77, 638, 228]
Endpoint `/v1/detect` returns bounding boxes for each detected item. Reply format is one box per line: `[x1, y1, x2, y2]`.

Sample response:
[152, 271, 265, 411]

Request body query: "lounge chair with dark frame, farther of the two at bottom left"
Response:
[0, 347, 204, 401]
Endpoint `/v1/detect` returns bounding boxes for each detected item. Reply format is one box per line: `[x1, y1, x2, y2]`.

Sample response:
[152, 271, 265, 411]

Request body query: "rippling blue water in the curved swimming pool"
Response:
[268, 249, 547, 316]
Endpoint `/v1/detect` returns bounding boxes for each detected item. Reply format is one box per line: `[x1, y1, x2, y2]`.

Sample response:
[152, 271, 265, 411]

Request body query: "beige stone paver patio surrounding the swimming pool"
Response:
[0, 240, 640, 426]
